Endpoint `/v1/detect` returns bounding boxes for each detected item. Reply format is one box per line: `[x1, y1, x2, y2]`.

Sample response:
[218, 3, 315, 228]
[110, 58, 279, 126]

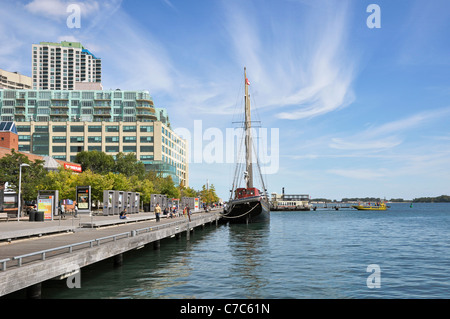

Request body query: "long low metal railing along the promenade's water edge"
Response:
[0, 214, 218, 271]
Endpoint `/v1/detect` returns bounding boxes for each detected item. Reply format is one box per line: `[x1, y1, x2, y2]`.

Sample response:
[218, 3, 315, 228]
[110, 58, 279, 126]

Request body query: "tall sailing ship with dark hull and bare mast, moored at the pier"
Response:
[223, 68, 270, 224]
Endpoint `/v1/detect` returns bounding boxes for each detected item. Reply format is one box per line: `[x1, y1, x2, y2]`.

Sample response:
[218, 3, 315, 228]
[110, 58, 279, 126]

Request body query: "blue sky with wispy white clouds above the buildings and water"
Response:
[0, 0, 450, 200]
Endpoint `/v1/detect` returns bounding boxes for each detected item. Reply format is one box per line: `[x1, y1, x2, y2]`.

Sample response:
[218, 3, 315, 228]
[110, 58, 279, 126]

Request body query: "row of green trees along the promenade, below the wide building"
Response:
[0, 150, 219, 203]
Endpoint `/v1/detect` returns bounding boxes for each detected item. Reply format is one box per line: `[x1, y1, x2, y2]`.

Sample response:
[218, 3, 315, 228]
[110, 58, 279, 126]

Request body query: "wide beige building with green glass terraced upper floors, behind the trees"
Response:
[0, 90, 189, 186]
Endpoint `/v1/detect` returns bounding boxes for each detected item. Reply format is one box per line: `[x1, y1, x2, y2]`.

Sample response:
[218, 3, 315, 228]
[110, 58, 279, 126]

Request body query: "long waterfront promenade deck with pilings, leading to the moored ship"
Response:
[0, 210, 221, 297]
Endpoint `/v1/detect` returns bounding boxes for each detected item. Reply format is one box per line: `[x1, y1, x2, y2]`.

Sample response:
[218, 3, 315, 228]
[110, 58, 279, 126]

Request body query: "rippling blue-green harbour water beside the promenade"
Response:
[43, 204, 450, 299]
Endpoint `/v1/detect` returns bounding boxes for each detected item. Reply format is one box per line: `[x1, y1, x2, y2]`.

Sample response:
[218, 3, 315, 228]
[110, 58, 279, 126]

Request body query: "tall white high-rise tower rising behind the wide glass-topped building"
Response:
[31, 41, 102, 90]
